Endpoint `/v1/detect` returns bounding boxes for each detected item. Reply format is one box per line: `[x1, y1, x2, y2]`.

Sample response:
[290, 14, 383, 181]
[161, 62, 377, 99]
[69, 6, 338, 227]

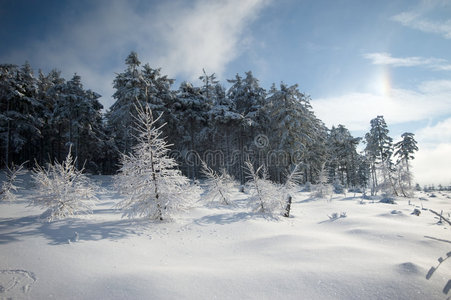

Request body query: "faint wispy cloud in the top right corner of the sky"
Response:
[392, 1, 451, 39]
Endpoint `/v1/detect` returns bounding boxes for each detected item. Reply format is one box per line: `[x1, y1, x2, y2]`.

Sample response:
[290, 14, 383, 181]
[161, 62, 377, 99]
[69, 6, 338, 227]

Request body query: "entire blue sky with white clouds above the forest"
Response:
[0, 0, 451, 185]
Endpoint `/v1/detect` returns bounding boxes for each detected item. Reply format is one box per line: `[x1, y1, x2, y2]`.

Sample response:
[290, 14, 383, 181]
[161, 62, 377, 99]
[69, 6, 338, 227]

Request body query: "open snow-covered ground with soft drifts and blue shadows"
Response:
[0, 176, 451, 299]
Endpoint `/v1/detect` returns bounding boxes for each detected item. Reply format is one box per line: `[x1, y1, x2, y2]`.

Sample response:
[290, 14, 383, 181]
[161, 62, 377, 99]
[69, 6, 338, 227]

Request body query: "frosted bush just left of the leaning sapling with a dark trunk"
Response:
[245, 161, 284, 214]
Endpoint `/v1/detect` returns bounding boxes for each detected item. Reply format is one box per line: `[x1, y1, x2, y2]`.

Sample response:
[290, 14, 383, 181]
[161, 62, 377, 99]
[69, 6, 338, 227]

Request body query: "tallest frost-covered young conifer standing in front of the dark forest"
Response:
[116, 105, 200, 221]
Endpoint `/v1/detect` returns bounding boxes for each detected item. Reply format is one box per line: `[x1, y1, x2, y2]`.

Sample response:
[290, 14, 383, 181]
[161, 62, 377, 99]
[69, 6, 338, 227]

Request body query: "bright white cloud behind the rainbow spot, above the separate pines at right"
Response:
[312, 81, 451, 130]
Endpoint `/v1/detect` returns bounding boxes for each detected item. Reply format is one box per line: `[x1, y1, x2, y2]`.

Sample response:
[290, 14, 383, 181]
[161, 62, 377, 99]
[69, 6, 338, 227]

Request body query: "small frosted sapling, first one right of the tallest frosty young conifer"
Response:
[202, 161, 234, 205]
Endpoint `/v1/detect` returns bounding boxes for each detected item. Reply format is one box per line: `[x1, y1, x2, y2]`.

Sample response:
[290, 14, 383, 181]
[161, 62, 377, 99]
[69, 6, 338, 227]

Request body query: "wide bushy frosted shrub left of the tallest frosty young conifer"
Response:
[31, 149, 97, 222]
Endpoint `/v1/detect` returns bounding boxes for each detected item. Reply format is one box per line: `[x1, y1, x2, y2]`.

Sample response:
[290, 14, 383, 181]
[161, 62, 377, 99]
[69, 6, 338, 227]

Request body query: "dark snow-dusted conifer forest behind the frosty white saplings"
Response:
[0, 52, 416, 192]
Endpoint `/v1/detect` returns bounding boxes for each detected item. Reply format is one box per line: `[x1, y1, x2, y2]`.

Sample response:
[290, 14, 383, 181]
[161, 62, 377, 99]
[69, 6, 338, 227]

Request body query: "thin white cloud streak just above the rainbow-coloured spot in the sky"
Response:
[363, 52, 451, 71]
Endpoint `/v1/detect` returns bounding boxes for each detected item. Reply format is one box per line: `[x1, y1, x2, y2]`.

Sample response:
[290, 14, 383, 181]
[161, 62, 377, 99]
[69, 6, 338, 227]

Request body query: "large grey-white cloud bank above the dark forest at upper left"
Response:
[1, 0, 269, 107]
